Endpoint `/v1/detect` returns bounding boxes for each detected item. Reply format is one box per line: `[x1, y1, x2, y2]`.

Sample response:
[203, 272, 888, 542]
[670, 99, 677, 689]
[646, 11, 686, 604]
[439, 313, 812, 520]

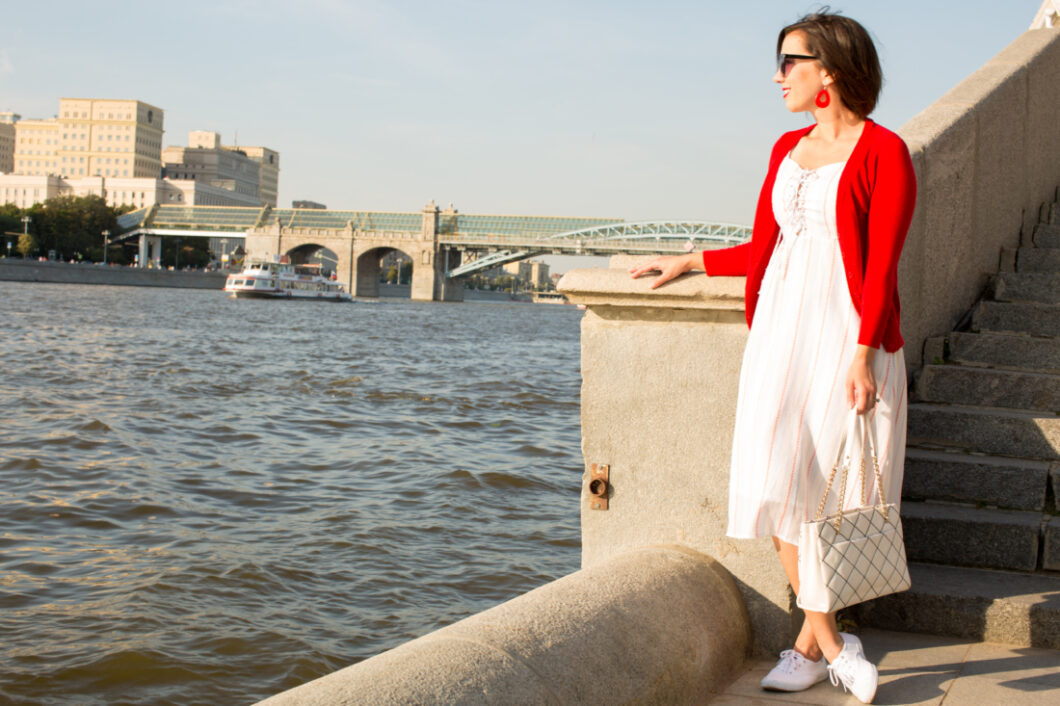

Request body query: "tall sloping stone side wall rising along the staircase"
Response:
[898, 29, 1060, 370]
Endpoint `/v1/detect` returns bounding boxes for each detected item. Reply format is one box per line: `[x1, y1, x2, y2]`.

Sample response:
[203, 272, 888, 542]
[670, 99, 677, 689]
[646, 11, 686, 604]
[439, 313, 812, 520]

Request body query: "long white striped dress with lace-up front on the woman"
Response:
[727, 156, 906, 544]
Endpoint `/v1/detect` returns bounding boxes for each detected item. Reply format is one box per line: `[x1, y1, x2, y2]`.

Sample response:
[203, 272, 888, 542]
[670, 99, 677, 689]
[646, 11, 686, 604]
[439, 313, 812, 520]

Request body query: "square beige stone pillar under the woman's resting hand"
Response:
[559, 265, 798, 653]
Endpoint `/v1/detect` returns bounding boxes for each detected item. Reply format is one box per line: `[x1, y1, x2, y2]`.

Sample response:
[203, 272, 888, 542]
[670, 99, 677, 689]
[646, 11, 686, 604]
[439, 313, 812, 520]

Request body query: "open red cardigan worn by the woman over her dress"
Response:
[703, 120, 917, 352]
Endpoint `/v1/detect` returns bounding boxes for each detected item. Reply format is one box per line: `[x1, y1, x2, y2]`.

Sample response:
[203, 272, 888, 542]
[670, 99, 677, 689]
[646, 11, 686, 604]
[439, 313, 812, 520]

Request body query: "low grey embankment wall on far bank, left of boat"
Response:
[0, 258, 228, 289]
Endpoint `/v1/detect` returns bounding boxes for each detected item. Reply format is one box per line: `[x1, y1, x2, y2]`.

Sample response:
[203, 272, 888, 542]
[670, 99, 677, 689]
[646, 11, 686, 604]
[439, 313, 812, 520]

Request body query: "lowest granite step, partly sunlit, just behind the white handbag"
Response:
[849, 563, 1060, 650]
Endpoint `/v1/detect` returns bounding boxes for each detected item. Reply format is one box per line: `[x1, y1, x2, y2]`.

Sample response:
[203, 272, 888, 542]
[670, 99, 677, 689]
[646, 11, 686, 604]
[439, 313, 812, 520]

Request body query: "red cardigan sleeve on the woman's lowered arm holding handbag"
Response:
[858, 135, 917, 348]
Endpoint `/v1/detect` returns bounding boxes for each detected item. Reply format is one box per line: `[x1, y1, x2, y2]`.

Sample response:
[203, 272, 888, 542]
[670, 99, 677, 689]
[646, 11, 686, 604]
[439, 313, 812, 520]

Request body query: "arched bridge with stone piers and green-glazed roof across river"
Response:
[113, 202, 750, 300]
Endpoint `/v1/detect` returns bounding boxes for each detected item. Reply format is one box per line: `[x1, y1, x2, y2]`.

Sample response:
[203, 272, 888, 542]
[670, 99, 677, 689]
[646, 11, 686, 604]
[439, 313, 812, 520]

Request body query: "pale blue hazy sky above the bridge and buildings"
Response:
[0, 0, 1041, 239]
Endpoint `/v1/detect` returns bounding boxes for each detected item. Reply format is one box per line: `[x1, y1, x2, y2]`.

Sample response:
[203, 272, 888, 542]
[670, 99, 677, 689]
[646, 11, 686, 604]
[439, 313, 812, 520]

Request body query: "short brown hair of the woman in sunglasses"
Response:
[777, 7, 883, 119]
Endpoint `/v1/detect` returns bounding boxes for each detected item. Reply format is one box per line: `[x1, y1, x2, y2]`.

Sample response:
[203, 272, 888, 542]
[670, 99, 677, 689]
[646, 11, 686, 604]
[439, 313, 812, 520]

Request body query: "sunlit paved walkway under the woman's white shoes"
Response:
[710, 630, 1060, 706]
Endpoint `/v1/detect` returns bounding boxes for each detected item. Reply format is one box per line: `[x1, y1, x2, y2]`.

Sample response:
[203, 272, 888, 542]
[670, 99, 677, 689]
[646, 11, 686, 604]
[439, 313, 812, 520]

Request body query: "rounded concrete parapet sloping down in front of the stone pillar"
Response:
[261, 547, 749, 706]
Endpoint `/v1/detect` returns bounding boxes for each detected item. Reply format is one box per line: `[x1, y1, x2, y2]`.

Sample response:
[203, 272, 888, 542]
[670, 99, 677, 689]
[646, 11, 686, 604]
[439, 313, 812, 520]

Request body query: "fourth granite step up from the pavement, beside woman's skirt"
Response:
[908, 402, 1060, 461]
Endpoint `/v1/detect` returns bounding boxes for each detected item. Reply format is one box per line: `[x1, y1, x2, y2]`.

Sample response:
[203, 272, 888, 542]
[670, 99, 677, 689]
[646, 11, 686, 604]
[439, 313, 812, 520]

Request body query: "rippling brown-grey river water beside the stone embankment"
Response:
[0, 282, 582, 706]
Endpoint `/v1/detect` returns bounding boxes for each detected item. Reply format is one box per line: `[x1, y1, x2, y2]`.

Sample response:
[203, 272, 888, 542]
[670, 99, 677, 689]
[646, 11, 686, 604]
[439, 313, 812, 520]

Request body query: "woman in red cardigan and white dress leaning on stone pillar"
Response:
[630, 13, 916, 703]
